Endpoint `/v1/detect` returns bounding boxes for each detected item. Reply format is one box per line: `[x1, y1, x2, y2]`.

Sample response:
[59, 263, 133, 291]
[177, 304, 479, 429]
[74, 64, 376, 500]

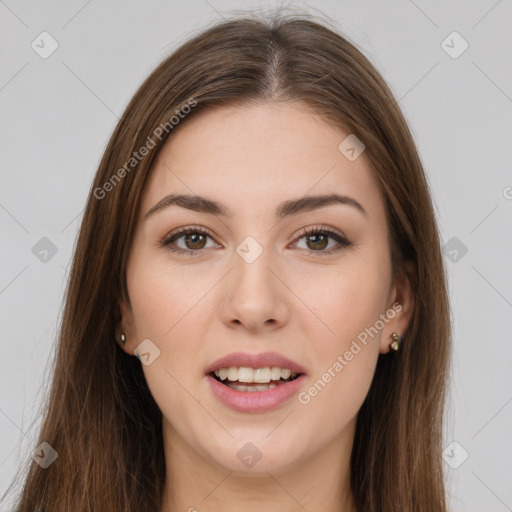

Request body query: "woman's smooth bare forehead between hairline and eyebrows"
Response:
[142, 102, 384, 222]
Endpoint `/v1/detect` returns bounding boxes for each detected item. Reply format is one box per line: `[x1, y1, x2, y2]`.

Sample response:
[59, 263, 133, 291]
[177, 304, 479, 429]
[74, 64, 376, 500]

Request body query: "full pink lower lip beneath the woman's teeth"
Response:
[206, 374, 306, 412]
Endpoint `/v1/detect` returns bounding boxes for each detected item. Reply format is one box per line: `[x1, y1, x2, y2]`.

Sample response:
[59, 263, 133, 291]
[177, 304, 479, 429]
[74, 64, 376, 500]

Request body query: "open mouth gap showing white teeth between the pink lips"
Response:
[209, 366, 304, 393]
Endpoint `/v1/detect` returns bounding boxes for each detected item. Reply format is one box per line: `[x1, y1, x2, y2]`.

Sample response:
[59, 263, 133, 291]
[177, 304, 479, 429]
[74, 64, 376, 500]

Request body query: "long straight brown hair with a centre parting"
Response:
[5, 12, 451, 512]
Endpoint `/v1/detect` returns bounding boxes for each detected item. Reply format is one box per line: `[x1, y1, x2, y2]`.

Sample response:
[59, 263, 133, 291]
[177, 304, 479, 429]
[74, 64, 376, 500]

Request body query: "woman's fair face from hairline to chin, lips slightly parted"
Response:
[120, 103, 412, 474]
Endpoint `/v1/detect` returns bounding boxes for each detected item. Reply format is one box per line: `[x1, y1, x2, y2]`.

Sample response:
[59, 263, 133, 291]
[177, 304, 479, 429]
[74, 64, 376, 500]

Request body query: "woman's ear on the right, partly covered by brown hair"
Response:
[379, 261, 415, 354]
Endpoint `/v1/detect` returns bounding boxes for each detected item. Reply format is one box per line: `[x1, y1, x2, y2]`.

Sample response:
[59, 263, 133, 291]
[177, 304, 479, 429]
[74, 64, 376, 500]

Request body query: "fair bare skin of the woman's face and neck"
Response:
[118, 103, 413, 512]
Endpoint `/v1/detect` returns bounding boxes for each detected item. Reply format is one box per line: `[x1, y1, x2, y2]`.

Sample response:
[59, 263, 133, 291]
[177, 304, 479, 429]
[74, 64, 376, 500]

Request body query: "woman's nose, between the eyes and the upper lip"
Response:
[220, 241, 290, 333]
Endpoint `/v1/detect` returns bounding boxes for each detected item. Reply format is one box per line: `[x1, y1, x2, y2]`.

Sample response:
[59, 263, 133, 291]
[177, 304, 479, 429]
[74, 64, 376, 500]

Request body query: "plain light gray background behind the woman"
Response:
[0, 0, 512, 512]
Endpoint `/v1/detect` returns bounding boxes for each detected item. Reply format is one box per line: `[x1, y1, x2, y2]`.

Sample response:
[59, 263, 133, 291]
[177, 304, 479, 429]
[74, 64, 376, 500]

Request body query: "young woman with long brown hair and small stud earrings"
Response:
[5, 9, 450, 512]
